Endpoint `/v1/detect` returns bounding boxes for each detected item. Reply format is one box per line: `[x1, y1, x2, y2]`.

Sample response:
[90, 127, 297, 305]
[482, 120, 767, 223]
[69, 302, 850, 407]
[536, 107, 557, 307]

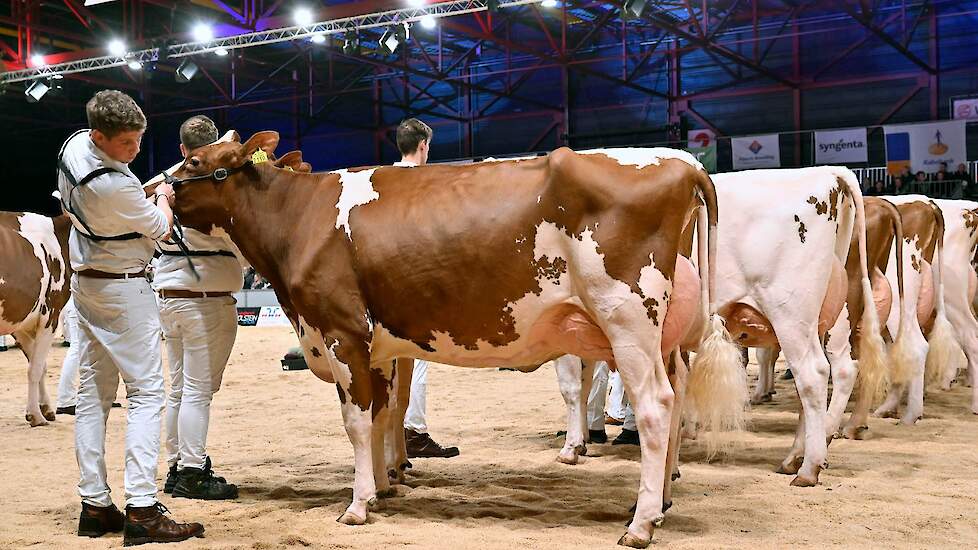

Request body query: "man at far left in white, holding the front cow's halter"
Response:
[58, 91, 204, 546]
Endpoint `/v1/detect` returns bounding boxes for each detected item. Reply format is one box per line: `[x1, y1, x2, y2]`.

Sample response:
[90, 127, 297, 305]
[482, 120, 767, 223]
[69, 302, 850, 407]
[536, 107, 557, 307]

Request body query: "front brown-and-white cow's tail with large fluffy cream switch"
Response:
[684, 171, 749, 456]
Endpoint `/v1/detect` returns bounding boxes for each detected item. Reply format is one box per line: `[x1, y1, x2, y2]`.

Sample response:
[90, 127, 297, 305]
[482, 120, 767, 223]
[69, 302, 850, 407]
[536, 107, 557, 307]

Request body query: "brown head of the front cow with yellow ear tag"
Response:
[172, 131, 279, 232]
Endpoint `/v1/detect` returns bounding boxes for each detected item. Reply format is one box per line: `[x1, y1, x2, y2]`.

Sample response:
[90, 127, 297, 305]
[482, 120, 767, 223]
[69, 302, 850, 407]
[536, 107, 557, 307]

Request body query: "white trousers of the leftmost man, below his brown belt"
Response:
[71, 275, 163, 506]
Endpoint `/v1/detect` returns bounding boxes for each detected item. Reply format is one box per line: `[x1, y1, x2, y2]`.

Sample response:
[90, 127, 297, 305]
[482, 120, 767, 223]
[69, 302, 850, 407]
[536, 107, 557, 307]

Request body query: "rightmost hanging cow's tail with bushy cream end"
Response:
[924, 201, 964, 388]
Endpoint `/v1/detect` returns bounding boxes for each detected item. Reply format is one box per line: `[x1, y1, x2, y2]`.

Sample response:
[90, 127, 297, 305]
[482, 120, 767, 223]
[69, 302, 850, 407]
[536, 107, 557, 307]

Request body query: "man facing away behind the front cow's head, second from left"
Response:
[153, 116, 244, 500]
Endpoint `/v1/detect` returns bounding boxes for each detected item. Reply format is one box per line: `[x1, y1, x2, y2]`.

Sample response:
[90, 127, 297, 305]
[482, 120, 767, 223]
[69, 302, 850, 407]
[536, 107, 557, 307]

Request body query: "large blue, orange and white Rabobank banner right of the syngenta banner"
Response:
[883, 120, 967, 174]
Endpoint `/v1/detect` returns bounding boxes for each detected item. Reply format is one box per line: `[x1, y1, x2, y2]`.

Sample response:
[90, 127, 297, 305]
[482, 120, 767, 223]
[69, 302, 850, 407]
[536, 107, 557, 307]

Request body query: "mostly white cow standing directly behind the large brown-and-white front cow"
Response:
[688, 166, 884, 486]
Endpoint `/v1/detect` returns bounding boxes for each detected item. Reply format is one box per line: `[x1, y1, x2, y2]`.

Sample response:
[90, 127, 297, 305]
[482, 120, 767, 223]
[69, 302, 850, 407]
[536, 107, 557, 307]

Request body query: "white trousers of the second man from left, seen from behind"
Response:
[160, 296, 238, 469]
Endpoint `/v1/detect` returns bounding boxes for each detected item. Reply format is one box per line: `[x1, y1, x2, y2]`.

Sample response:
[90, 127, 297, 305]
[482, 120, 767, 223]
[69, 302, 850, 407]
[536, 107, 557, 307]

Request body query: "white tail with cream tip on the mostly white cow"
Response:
[836, 168, 888, 408]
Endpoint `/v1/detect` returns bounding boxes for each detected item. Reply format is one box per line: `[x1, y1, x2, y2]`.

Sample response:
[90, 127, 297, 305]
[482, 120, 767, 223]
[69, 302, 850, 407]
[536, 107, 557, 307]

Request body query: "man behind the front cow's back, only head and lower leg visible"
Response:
[394, 118, 459, 458]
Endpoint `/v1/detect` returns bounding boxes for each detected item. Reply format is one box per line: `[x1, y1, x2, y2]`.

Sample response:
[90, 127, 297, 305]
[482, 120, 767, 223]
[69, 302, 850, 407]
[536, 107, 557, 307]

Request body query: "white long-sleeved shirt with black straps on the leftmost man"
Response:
[58, 130, 170, 273]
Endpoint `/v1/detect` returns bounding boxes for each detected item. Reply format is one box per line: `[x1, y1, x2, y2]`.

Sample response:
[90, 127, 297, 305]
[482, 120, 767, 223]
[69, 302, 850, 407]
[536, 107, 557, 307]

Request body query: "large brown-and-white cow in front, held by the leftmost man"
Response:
[168, 132, 736, 547]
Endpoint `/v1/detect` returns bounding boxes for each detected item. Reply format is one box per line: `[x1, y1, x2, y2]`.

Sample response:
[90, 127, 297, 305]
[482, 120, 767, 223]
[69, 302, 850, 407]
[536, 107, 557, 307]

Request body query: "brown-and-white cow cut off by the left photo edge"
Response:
[0, 212, 71, 426]
